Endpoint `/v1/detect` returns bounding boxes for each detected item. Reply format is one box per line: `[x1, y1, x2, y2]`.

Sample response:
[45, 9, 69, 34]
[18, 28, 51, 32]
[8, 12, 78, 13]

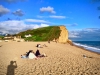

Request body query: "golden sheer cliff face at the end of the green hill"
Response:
[58, 26, 68, 43]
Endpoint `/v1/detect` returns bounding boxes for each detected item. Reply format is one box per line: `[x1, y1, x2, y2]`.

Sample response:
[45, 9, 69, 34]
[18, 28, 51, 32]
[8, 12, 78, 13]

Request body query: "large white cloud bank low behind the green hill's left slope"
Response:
[0, 20, 49, 34]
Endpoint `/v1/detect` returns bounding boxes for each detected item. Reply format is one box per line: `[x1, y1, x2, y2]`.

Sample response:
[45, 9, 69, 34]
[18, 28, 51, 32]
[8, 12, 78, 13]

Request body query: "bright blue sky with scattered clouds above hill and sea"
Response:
[0, 0, 100, 41]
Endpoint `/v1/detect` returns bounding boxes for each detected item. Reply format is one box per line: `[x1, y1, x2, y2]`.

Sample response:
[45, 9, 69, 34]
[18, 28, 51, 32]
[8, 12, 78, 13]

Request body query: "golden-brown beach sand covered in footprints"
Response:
[0, 42, 100, 75]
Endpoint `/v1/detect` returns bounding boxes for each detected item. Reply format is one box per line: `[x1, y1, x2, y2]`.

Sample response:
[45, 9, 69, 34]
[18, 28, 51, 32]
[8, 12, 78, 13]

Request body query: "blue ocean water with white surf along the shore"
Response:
[73, 41, 100, 53]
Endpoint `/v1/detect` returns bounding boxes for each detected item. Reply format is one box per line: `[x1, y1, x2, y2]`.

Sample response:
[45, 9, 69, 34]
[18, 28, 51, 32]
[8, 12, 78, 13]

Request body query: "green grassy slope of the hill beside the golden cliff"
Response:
[17, 26, 61, 41]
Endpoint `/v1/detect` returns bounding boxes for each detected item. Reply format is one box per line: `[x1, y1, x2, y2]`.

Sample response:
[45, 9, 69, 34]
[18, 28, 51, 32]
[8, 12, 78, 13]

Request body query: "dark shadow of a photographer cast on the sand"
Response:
[6, 61, 17, 75]
